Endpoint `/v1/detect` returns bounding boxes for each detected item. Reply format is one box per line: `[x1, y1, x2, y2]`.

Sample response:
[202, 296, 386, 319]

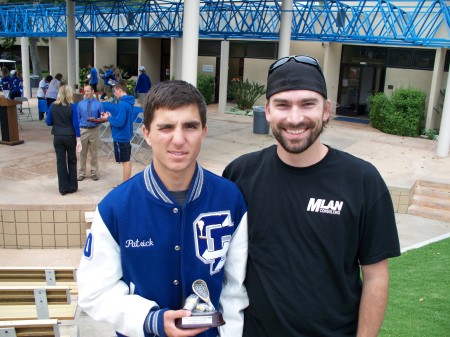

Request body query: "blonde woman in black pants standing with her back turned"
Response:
[46, 85, 81, 195]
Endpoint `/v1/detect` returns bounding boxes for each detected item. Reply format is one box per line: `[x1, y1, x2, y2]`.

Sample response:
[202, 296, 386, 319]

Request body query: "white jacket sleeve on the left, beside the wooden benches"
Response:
[77, 208, 159, 337]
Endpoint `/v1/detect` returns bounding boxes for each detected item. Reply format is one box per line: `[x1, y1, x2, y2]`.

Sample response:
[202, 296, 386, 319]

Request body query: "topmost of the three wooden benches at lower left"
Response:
[0, 267, 78, 294]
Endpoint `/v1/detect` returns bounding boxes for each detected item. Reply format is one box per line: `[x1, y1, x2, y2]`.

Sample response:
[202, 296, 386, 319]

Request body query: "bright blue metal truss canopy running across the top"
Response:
[0, 0, 450, 48]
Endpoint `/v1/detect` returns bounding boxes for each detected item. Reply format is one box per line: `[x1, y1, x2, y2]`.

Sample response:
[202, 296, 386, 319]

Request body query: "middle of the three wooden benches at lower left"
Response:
[0, 286, 77, 322]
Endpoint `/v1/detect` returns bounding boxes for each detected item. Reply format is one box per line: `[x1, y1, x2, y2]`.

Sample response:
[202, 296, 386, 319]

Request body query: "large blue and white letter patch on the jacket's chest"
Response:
[193, 211, 234, 275]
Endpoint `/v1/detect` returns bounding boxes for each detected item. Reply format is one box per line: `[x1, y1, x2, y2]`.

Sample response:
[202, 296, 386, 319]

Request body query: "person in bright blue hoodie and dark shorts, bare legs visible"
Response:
[102, 82, 134, 182]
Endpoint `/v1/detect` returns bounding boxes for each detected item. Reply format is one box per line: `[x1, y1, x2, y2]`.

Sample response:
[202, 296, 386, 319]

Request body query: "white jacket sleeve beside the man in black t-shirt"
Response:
[219, 213, 248, 337]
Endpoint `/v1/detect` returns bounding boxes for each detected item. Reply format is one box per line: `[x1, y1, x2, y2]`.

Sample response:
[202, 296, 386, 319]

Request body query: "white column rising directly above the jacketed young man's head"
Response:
[181, 0, 200, 86]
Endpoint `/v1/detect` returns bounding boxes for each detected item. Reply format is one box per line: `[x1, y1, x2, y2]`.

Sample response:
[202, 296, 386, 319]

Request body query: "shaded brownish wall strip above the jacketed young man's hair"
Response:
[138, 38, 161, 85]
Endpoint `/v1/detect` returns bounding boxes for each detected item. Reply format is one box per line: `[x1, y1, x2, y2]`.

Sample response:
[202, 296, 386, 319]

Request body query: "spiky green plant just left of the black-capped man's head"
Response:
[228, 79, 266, 110]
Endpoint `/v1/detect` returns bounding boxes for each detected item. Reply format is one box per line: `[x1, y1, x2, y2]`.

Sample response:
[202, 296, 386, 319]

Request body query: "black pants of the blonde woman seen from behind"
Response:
[53, 136, 78, 193]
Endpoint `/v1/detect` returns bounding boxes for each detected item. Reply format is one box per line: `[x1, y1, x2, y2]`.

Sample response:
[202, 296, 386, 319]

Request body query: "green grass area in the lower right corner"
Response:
[379, 239, 450, 337]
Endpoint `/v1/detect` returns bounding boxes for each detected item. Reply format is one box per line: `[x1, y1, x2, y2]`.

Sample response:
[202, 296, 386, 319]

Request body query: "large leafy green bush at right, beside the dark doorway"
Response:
[369, 88, 426, 137]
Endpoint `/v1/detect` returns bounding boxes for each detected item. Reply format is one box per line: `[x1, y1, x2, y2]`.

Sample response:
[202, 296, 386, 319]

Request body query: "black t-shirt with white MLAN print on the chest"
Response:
[224, 146, 400, 337]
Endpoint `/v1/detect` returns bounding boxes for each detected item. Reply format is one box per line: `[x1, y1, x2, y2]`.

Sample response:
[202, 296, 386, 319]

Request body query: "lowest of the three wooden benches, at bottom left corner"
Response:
[0, 319, 60, 337]
